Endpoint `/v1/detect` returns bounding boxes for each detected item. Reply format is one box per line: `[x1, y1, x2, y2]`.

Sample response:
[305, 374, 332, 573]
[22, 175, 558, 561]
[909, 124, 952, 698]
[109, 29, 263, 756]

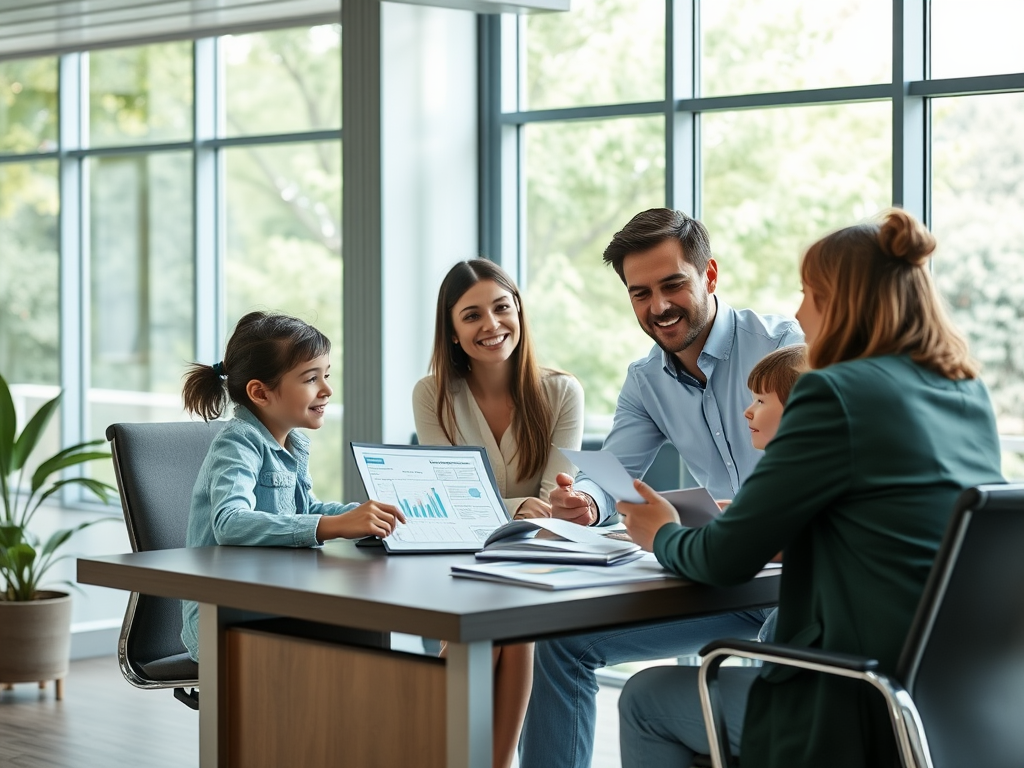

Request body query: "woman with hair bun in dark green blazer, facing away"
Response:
[618, 210, 1004, 768]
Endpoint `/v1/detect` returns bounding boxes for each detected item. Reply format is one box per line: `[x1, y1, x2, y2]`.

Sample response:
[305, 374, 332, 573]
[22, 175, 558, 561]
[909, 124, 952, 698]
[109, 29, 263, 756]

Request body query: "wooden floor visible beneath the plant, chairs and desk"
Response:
[0, 656, 620, 768]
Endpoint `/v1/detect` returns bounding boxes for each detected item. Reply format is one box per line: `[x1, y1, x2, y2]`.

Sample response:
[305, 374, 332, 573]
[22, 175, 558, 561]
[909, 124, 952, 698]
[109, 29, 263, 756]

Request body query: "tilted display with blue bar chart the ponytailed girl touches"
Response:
[352, 442, 509, 553]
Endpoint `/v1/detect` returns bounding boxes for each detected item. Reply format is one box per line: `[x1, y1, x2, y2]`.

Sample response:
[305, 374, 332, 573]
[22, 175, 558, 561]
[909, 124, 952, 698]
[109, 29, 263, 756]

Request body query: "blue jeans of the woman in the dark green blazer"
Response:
[618, 667, 761, 768]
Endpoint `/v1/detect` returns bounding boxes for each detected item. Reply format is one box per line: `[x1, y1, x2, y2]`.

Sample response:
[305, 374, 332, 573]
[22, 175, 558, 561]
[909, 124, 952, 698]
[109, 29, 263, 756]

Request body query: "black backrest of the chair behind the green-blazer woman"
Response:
[897, 484, 1024, 768]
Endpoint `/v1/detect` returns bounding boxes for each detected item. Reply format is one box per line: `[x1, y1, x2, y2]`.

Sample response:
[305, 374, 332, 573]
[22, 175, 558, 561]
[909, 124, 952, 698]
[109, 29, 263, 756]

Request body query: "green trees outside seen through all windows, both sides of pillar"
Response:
[0, 7, 1024, 498]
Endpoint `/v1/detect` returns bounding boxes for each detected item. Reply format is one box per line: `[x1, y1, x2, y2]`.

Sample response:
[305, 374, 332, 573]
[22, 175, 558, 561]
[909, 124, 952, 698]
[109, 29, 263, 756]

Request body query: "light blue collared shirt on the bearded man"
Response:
[574, 297, 804, 522]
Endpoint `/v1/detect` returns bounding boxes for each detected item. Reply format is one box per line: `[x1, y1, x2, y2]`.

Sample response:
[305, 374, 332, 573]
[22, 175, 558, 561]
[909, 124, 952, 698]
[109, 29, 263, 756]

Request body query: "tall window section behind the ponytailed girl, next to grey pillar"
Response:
[221, 26, 343, 499]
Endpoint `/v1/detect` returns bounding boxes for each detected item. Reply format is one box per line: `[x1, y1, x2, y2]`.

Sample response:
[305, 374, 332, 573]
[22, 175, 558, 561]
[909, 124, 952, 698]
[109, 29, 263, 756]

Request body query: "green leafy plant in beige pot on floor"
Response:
[0, 376, 117, 699]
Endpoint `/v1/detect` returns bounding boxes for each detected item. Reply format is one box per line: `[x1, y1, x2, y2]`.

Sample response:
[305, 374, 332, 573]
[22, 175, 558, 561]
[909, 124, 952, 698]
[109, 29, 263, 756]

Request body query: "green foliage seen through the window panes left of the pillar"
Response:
[0, 25, 342, 498]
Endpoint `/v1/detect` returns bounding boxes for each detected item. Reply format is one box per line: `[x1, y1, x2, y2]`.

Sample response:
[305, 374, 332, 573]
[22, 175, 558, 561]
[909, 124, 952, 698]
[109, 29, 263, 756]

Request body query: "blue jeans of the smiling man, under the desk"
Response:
[519, 609, 770, 768]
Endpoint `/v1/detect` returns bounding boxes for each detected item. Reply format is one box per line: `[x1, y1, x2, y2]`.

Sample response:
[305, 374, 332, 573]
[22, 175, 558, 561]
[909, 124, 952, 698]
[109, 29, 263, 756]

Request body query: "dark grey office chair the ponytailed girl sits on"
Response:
[106, 422, 223, 710]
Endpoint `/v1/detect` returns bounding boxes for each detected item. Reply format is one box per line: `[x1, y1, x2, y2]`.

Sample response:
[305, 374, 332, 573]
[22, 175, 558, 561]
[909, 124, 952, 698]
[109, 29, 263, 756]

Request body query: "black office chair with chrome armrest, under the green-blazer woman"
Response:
[699, 484, 1024, 768]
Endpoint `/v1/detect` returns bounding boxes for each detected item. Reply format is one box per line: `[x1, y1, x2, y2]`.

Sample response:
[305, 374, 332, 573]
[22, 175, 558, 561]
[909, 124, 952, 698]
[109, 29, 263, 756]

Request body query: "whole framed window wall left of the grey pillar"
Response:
[0, 25, 342, 501]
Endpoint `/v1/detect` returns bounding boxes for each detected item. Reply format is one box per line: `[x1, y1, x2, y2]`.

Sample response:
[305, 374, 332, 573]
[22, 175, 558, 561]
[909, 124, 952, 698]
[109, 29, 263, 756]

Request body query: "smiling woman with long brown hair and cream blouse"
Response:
[413, 259, 583, 768]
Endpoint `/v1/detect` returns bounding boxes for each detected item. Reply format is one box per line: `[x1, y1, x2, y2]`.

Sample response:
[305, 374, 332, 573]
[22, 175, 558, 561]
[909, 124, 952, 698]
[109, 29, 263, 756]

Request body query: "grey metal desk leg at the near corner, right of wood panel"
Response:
[446, 641, 494, 768]
